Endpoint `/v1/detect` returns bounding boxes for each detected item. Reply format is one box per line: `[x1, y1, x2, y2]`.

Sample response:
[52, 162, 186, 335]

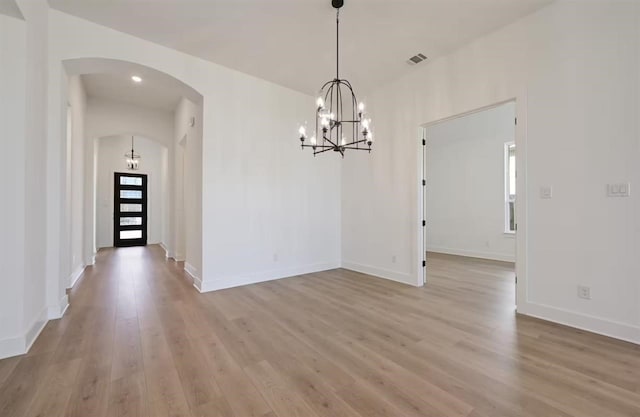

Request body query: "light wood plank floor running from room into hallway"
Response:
[0, 247, 640, 417]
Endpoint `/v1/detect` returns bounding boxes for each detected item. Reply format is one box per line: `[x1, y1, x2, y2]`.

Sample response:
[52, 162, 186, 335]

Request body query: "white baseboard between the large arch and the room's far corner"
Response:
[193, 261, 340, 292]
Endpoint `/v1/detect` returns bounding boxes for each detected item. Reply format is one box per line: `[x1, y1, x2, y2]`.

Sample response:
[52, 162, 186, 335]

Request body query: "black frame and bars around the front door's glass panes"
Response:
[113, 172, 148, 248]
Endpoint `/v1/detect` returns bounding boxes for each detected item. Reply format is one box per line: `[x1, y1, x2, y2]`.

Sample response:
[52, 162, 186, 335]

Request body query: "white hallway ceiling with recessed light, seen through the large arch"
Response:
[80, 71, 185, 112]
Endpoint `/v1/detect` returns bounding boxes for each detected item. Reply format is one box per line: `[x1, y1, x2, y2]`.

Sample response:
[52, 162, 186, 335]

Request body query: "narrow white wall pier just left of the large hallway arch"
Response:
[16, 0, 51, 352]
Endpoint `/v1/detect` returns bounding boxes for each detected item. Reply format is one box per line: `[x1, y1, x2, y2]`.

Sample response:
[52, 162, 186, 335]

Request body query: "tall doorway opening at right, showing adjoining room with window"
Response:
[421, 100, 520, 304]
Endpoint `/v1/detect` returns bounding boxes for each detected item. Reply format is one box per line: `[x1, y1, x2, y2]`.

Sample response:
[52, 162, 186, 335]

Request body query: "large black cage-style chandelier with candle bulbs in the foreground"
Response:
[298, 0, 373, 158]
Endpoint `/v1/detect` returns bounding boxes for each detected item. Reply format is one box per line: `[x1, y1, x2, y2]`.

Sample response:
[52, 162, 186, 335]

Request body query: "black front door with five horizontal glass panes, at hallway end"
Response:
[113, 172, 147, 247]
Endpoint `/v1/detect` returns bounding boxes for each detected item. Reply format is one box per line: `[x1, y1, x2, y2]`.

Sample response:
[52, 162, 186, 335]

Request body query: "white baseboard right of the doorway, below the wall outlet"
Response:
[518, 302, 640, 344]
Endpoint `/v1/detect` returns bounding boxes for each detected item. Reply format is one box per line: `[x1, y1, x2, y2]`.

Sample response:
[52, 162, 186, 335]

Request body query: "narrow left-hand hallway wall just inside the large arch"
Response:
[66, 75, 87, 287]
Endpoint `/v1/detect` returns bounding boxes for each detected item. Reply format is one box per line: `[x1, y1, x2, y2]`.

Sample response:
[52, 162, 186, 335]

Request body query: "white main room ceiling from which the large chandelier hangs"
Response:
[49, 0, 553, 94]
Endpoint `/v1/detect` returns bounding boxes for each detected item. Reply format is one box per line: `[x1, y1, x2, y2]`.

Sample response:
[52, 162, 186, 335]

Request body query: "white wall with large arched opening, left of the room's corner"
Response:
[49, 10, 342, 298]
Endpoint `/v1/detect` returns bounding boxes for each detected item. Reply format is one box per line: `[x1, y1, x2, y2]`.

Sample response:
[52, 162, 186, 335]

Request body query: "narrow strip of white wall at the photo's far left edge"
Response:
[0, 15, 27, 358]
